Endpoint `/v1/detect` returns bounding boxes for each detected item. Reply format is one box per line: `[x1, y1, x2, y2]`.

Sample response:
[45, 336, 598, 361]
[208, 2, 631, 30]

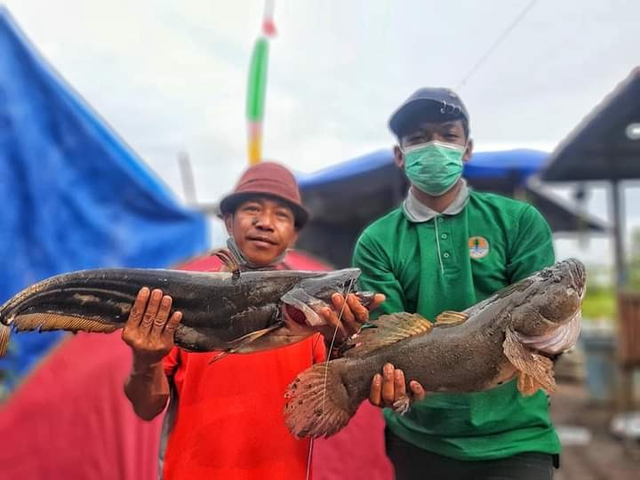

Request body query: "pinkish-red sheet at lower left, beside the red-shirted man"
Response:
[0, 331, 161, 480]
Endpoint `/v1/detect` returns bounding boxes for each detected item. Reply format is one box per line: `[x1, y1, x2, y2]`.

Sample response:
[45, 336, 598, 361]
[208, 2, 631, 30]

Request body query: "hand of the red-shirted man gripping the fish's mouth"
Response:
[320, 293, 385, 342]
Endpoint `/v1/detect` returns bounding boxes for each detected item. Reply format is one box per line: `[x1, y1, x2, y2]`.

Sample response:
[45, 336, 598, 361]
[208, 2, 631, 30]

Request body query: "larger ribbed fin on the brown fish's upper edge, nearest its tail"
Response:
[344, 312, 433, 357]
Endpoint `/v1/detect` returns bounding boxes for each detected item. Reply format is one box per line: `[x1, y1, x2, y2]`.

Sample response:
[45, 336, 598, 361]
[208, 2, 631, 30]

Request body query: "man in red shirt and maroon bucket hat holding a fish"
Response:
[122, 162, 384, 480]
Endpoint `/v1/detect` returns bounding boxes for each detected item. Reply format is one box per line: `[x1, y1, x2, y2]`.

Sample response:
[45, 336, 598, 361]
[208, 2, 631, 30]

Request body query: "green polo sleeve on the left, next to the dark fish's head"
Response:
[353, 232, 406, 319]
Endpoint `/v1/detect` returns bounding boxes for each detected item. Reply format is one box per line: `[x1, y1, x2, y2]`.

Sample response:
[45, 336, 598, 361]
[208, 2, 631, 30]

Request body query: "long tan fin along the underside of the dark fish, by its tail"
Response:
[11, 312, 122, 333]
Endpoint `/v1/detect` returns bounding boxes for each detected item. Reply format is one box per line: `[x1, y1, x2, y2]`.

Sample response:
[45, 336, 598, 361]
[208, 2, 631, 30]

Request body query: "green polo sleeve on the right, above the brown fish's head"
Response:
[507, 205, 555, 283]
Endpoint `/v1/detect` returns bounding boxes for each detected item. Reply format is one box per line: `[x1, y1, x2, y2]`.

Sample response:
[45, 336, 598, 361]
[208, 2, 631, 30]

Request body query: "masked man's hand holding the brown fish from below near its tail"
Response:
[369, 363, 426, 415]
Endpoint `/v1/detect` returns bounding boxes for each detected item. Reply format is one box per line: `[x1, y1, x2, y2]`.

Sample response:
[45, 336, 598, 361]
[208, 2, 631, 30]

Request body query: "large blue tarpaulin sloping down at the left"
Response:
[0, 6, 208, 396]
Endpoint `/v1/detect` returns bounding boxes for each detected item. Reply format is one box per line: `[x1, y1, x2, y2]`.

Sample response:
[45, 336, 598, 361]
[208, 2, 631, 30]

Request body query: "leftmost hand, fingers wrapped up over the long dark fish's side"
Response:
[122, 287, 182, 368]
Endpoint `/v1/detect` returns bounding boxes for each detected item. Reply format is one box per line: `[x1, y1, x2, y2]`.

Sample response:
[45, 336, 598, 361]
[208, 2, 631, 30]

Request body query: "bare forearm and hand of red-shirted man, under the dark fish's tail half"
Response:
[122, 287, 182, 420]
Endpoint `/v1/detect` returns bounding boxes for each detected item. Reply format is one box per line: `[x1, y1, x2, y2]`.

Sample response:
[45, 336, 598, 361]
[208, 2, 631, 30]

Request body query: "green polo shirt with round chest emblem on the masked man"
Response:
[353, 191, 560, 460]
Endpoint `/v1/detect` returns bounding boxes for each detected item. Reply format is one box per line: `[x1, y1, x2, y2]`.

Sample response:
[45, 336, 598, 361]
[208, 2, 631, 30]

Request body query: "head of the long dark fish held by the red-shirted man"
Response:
[281, 268, 374, 329]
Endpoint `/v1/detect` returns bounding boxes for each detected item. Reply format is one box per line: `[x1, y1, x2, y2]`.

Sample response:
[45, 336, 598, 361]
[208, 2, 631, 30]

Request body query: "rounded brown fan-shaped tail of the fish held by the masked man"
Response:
[284, 360, 355, 438]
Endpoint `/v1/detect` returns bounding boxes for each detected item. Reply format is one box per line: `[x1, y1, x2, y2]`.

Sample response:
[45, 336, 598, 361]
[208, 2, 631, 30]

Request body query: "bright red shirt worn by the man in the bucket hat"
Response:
[164, 253, 325, 480]
